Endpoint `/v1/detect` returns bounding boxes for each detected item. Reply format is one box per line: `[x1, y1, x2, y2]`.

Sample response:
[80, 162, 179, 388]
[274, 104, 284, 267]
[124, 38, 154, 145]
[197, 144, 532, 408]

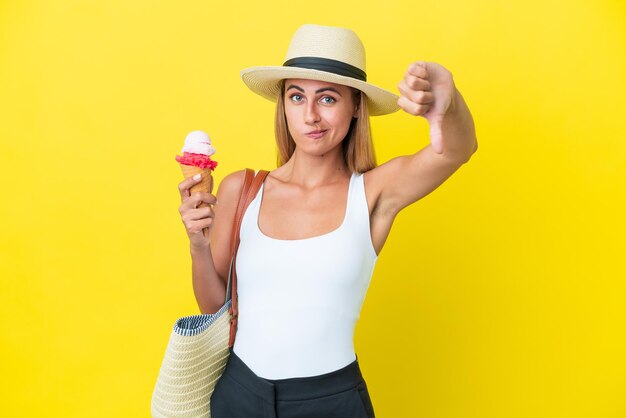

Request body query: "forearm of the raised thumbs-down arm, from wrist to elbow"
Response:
[441, 87, 478, 162]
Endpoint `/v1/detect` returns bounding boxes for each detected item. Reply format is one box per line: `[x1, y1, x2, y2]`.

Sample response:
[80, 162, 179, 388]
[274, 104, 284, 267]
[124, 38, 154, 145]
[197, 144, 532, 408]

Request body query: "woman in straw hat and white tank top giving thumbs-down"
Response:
[179, 25, 477, 418]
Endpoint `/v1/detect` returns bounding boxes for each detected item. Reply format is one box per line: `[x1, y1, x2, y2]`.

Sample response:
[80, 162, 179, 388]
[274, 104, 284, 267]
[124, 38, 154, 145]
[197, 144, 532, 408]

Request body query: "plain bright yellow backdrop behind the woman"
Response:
[0, 0, 626, 418]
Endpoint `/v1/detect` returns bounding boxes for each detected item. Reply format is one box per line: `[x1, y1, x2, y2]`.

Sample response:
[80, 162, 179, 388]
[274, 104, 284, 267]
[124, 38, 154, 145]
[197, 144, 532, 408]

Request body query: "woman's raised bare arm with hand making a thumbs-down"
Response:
[368, 63, 478, 218]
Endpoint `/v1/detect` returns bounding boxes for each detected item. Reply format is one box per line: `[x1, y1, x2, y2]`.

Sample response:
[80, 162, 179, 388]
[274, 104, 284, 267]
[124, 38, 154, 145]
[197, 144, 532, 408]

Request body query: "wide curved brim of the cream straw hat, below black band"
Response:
[241, 66, 400, 116]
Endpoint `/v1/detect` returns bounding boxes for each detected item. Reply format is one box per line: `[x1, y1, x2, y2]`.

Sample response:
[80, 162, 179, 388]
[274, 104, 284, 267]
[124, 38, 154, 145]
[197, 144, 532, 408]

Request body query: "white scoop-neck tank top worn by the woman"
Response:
[233, 173, 378, 379]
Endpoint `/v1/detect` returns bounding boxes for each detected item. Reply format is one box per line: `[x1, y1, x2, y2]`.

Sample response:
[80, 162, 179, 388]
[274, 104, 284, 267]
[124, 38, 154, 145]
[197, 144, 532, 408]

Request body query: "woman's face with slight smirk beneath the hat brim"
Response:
[284, 79, 358, 155]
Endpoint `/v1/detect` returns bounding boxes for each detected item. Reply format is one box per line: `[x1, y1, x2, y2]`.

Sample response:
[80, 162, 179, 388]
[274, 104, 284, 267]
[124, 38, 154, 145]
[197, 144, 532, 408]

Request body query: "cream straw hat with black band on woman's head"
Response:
[241, 24, 399, 116]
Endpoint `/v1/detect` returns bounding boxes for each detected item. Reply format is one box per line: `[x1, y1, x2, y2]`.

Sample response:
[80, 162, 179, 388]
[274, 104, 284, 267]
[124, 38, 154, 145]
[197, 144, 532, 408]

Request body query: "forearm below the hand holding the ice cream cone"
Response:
[190, 246, 226, 313]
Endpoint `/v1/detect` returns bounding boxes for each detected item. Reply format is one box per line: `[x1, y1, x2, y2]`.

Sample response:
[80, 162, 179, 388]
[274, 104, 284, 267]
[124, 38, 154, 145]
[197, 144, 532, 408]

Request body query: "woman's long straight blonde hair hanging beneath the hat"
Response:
[274, 80, 377, 173]
